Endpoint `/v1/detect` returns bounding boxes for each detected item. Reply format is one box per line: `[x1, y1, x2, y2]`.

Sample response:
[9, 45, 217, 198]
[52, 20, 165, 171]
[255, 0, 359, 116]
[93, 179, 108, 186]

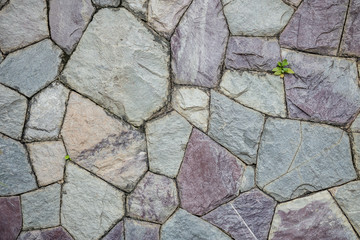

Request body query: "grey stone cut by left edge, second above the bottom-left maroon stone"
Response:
[0, 84, 27, 139]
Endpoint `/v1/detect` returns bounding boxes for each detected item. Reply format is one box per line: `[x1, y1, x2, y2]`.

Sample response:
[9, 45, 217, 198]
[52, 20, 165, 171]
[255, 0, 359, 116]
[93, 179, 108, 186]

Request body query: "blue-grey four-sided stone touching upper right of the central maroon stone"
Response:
[209, 91, 264, 164]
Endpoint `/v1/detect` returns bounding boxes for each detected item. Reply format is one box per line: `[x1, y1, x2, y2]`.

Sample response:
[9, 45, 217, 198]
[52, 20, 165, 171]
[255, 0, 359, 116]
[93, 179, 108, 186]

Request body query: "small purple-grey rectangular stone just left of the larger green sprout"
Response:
[225, 36, 281, 71]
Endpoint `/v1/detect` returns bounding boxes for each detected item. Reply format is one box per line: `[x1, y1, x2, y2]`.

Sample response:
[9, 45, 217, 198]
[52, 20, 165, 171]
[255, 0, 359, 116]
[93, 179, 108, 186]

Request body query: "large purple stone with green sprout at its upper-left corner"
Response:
[283, 49, 360, 125]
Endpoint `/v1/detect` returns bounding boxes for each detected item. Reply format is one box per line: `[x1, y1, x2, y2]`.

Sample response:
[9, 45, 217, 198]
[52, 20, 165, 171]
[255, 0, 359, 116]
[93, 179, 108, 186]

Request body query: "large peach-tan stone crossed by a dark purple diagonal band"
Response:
[61, 93, 147, 191]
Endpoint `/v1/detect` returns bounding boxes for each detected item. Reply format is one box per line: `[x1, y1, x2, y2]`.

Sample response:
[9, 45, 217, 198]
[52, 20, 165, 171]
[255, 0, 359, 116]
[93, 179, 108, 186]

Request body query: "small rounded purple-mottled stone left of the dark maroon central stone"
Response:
[125, 172, 179, 223]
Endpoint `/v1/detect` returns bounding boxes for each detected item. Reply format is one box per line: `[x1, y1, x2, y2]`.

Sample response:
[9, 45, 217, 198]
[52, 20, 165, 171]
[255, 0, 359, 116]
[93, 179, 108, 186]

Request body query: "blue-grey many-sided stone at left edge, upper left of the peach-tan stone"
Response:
[0, 39, 62, 97]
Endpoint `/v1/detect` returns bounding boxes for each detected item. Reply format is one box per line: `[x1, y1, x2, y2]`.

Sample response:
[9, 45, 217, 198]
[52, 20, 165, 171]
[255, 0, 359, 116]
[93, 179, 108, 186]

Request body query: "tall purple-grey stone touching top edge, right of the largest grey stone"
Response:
[171, 0, 229, 88]
